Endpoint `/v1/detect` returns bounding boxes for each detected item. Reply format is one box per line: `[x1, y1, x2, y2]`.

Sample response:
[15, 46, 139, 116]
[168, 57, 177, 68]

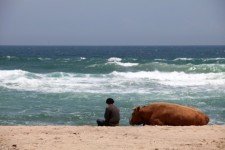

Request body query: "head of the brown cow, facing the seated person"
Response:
[130, 106, 143, 125]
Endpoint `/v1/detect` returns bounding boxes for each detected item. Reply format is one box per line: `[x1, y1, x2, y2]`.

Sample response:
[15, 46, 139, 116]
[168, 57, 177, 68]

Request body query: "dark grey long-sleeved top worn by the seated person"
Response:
[104, 104, 120, 124]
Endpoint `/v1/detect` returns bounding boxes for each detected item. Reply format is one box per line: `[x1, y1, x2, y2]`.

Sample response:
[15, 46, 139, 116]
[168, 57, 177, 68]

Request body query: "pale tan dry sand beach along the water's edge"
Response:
[0, 125, 225, 150]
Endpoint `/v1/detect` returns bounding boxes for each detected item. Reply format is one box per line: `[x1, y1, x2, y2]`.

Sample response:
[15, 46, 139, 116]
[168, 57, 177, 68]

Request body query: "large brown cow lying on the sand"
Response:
[130, 102, 209, 126]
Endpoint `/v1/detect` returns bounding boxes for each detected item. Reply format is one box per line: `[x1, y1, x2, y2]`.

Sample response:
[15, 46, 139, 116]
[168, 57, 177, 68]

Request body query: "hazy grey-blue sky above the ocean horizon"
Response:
[0, 0, 225, 45]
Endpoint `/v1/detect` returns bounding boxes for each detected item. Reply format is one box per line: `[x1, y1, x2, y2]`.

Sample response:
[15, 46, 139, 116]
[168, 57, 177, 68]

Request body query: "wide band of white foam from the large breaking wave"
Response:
[0, 70, 225, 93]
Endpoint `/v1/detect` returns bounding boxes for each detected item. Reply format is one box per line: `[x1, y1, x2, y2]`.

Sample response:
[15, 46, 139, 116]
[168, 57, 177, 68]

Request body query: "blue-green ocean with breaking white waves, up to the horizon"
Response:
[0, 46, 225, 126]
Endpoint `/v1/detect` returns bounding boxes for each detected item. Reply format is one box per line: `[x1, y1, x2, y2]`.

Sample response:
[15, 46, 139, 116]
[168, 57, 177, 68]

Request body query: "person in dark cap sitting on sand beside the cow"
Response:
[97, 98, 120, 126]
